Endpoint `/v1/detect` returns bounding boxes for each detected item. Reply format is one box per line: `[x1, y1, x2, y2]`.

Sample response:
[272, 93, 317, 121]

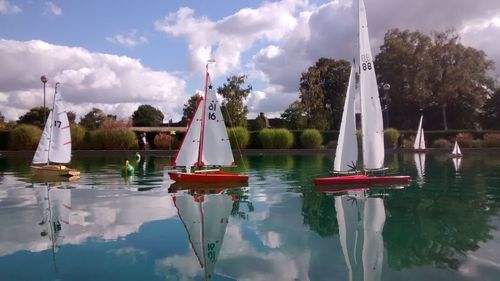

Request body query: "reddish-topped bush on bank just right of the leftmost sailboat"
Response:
[90, 119, 137, 150]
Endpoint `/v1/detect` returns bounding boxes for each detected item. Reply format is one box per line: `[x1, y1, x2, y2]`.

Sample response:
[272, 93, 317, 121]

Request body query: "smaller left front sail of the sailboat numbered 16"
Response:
[174, 99, 204, 167]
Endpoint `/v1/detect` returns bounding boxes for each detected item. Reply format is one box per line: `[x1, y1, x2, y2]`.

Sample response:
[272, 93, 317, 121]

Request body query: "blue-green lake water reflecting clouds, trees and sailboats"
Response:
[0, 150, 500, 281]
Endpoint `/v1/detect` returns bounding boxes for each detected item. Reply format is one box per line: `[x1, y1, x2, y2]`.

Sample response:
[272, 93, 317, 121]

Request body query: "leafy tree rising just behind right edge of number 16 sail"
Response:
[217, 75, 252, 128]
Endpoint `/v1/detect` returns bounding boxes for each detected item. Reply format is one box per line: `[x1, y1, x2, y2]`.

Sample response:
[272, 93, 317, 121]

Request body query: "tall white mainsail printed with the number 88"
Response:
[358, 0, 385, 170]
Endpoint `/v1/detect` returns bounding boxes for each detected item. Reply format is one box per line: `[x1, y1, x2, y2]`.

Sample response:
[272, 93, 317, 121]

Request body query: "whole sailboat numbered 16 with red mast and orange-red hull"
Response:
[168, 59, 248, 183]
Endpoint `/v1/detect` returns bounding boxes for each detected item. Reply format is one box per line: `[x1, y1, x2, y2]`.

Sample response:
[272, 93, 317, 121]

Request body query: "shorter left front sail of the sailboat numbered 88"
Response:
[333, 66, 358, 172]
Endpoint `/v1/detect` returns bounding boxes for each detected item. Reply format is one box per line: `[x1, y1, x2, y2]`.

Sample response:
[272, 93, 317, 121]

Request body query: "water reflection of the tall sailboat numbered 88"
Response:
[320, 186, 404, 281]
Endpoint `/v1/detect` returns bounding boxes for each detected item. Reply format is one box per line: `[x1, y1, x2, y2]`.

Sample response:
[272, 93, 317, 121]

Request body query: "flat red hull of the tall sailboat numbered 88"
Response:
[314, 175, 411, 185]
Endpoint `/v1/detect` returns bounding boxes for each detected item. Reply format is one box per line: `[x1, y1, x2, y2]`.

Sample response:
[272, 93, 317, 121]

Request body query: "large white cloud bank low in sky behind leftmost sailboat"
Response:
[0, 39, 188, 120]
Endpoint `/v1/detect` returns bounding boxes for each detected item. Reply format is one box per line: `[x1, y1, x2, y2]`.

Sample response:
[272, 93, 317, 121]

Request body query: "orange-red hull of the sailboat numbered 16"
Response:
[168, 168, 248, 183]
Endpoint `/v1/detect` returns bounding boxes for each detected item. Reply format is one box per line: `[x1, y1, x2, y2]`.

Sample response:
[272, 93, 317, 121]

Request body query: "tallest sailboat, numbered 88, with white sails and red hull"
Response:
[314, 0, 410, 185]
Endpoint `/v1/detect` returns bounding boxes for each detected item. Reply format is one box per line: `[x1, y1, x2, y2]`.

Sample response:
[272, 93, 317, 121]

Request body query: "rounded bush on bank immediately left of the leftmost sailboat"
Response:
[9, 125, 42, 150]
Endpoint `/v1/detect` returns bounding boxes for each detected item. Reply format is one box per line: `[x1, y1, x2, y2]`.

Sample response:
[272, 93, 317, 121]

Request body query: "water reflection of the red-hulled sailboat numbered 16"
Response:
[169, 180, 243, 280]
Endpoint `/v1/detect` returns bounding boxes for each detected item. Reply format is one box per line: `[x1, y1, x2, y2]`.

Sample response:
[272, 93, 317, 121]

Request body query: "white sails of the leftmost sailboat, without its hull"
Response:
[33, 86, 71, 164]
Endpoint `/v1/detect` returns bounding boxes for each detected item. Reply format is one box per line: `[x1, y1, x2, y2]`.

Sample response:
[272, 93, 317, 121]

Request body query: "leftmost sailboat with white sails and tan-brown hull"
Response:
[31, 83, 80, 177]
